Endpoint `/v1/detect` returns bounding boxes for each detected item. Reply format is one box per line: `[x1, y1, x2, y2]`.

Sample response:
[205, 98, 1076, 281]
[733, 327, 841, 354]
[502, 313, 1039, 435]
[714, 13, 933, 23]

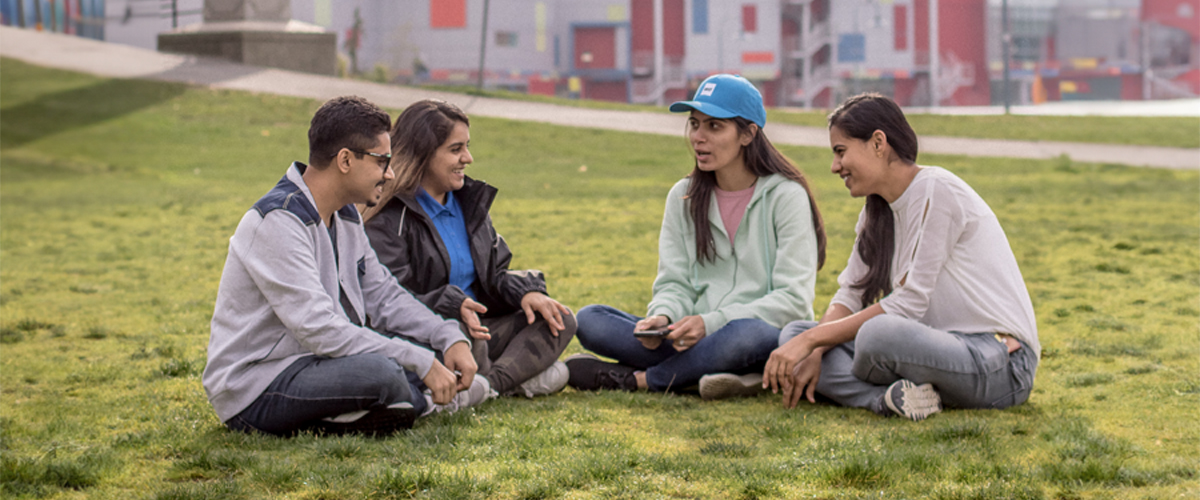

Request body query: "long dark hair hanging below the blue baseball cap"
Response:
[688, 116, 826, 270]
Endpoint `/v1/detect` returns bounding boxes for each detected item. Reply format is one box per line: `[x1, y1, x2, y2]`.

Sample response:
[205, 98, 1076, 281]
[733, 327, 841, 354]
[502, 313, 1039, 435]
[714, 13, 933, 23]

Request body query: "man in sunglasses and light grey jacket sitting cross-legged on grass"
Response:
[204, 97, 493, 435]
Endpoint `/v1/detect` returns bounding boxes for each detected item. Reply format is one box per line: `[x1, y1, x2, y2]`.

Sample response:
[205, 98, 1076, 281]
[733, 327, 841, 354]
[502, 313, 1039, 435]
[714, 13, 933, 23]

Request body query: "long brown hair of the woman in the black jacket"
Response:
[362, 100, 470, 221]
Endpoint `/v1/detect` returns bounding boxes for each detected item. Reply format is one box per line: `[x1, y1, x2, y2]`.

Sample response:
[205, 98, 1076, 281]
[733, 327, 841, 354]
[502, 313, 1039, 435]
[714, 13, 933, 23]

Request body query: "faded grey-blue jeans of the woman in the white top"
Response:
[779, 314, 1038, 415]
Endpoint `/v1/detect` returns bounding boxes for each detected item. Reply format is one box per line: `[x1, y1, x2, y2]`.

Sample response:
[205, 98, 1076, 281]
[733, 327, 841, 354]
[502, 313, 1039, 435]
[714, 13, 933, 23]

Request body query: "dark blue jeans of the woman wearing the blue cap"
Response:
[575, 305, 779, 392]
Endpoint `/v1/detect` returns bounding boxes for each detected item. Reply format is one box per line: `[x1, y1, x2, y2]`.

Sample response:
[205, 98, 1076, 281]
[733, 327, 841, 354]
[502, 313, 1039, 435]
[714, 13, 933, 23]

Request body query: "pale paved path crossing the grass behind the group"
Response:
[0, 26, 1200, 169]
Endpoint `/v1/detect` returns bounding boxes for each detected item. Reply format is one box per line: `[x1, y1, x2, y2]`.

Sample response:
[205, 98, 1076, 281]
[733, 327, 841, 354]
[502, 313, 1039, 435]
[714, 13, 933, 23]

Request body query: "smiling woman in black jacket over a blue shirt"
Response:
[364, 100, 575, 397]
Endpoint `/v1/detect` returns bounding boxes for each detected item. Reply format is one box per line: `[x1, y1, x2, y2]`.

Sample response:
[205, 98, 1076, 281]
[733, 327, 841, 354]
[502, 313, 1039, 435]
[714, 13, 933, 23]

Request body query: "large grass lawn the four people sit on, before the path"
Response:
[0, 60, 1200, 499]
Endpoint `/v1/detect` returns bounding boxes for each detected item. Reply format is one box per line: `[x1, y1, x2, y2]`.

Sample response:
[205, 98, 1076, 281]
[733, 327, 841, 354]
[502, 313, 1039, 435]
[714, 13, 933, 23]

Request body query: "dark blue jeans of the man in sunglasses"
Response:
[226, 354, 426, 435]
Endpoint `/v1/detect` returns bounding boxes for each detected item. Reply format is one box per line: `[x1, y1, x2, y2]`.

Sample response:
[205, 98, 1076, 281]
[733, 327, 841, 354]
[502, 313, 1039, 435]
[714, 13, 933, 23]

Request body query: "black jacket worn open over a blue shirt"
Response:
[366, 177, 546, 320]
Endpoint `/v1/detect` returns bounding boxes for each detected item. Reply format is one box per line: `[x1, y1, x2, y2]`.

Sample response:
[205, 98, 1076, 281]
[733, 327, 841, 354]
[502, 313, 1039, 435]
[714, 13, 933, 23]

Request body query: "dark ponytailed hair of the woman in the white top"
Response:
[829, 94, 917, 308]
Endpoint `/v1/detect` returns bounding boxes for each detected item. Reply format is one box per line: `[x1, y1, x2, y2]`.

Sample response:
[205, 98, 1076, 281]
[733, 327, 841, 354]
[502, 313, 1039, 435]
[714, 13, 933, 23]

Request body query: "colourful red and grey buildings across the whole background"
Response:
[7, 0, 1200, 108]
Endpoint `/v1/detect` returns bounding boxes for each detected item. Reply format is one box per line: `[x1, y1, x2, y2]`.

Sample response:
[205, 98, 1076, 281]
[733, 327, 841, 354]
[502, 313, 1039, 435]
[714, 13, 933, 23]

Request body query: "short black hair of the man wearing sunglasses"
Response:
[308, 96, 391, 168]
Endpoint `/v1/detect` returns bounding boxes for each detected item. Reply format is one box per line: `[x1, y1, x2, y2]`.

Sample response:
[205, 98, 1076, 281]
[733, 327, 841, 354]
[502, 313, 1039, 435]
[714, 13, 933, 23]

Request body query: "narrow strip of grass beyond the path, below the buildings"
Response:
[408, 80, 1200, 147]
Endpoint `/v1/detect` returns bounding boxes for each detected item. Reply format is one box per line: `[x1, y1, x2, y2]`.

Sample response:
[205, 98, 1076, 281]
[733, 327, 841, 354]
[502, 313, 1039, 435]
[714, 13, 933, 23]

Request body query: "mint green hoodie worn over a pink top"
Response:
[647, 174, 817, 335]
